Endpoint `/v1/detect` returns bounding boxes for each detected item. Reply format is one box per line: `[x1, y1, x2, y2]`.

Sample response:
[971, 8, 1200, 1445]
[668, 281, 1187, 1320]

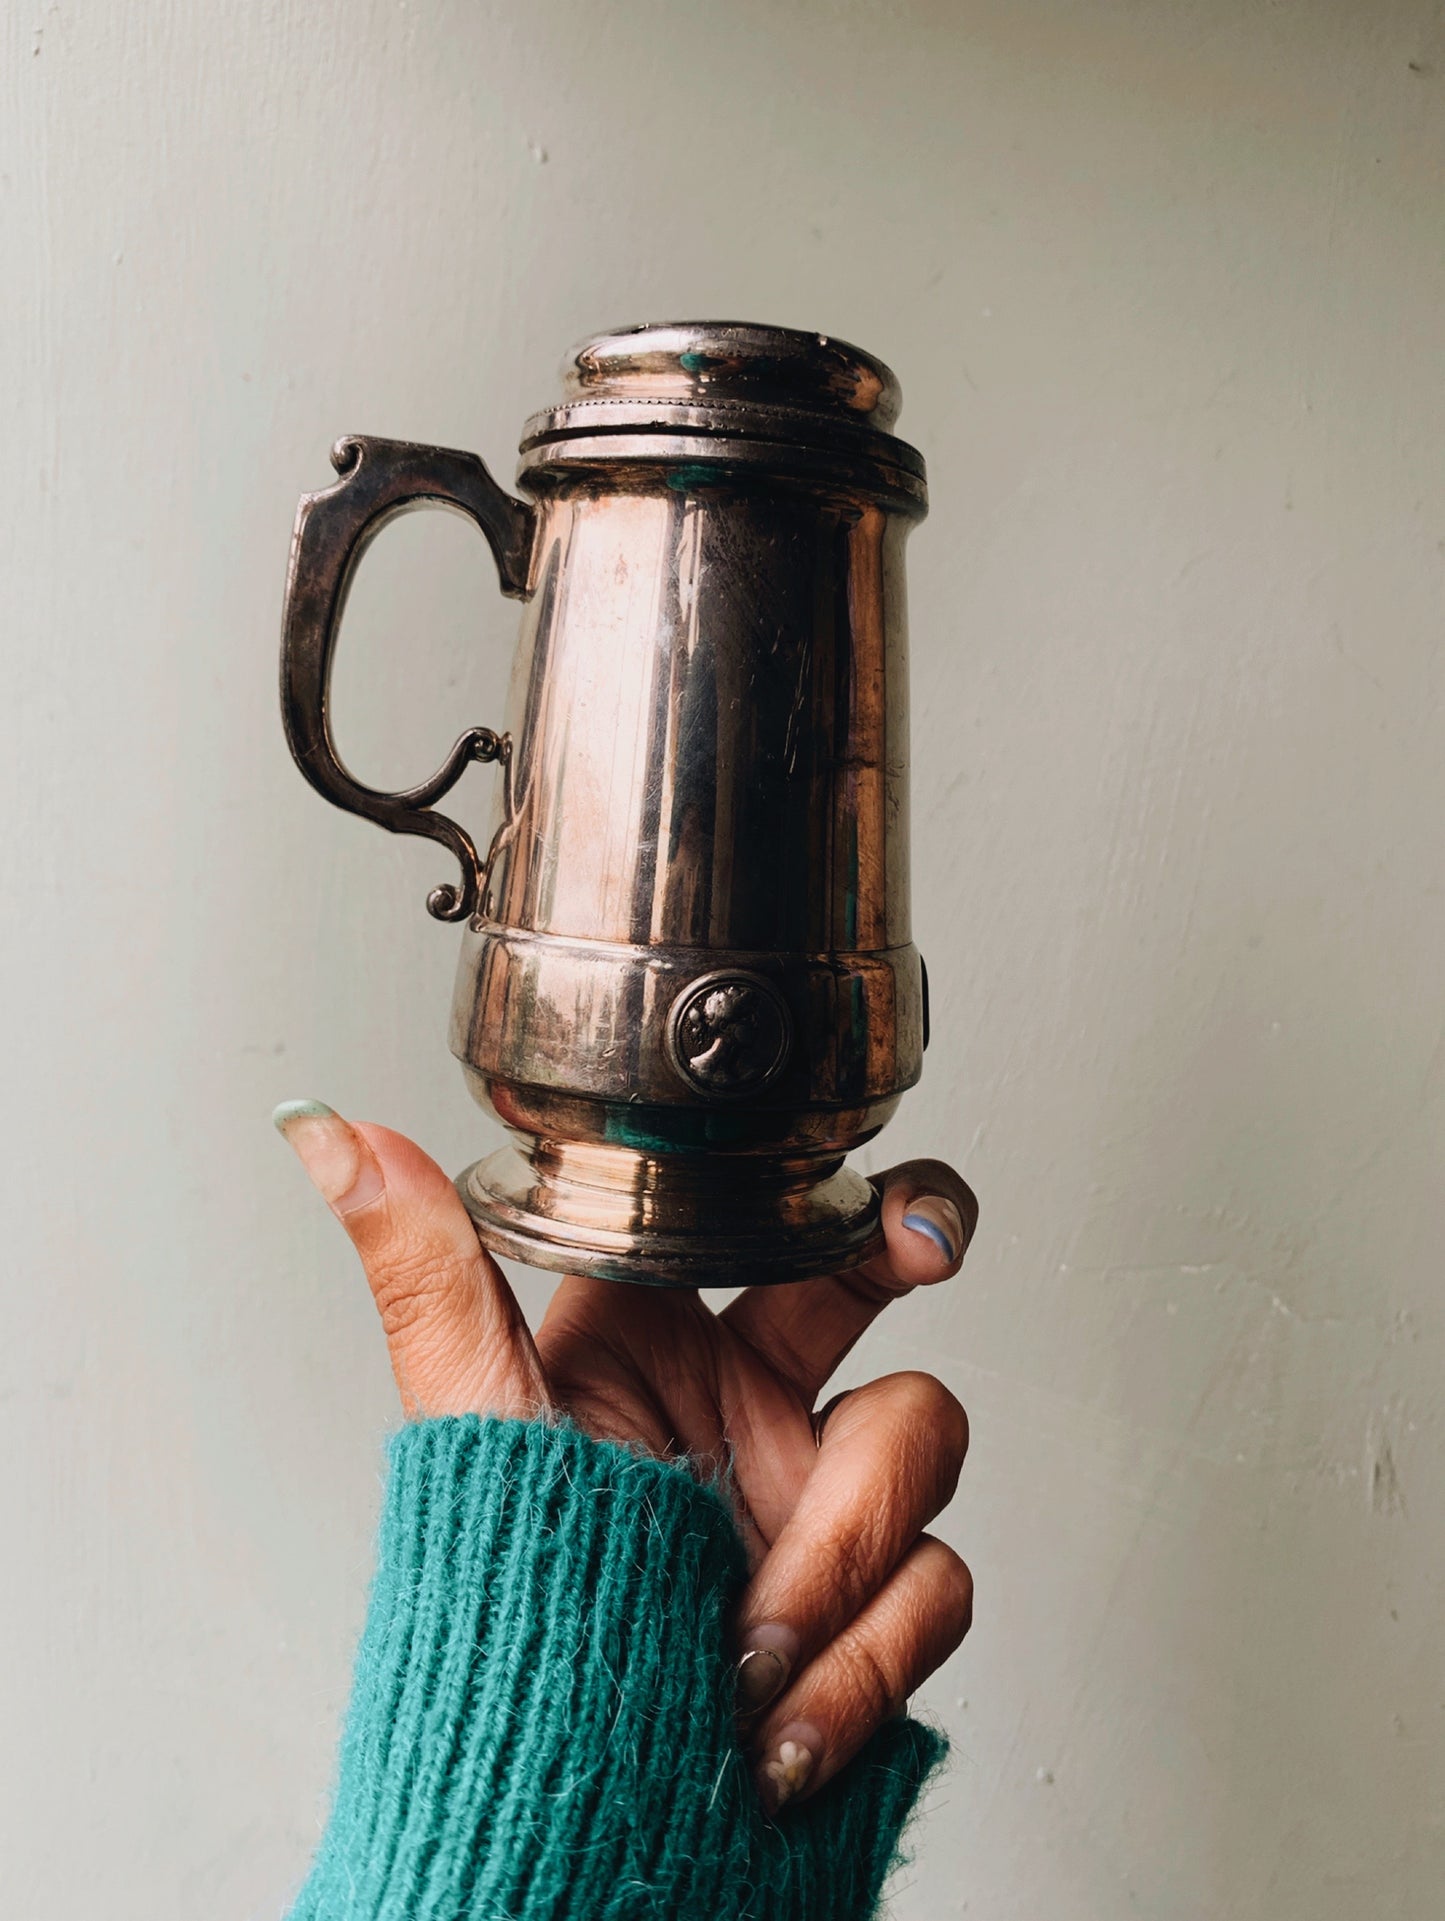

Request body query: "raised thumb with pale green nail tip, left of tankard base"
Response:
[273, 1101, 548, 1420]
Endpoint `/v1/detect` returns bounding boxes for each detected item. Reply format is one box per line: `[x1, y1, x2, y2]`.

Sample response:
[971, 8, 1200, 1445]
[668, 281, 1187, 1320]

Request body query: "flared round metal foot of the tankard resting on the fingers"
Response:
[457, 1147, 882, 1287]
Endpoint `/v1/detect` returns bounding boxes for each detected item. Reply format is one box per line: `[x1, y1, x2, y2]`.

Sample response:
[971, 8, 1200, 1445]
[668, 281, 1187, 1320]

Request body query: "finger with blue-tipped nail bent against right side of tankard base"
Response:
[723, 1160, 978, 1402]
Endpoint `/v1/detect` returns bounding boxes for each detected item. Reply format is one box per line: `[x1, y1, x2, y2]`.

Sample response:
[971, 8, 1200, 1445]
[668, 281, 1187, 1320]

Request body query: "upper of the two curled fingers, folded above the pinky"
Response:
[736, 1374, 968, 1714]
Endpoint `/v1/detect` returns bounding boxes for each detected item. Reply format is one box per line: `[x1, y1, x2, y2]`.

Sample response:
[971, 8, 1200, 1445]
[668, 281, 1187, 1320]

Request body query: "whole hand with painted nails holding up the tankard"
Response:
[277, 1101, 978, 1810]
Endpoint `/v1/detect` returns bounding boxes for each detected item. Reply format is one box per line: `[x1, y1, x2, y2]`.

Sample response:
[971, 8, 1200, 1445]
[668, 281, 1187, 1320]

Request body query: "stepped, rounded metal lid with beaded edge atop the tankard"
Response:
[519, 321, 926, 511]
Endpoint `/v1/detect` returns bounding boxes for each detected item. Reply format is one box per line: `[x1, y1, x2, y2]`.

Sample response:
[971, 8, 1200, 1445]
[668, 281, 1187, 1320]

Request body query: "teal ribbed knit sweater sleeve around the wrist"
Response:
[290, 1416, 943, 1921]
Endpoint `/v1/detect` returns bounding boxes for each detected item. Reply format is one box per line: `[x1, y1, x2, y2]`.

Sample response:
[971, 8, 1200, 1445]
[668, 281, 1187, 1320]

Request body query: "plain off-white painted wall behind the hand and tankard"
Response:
[0, 0, 1445, 1921]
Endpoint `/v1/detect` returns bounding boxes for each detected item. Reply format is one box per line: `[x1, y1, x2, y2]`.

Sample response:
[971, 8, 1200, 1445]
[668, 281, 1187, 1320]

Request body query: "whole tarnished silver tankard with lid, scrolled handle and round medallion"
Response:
[281, 321, 928, 1287]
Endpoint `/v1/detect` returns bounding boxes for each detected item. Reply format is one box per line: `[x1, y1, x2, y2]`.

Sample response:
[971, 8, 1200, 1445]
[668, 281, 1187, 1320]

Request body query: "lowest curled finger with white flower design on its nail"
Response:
[753, 1535, 974, 1813]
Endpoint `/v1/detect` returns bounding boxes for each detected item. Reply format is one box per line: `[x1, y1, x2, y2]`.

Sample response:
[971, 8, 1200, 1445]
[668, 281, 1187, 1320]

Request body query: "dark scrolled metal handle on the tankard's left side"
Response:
[281, 434, 536, 920]
